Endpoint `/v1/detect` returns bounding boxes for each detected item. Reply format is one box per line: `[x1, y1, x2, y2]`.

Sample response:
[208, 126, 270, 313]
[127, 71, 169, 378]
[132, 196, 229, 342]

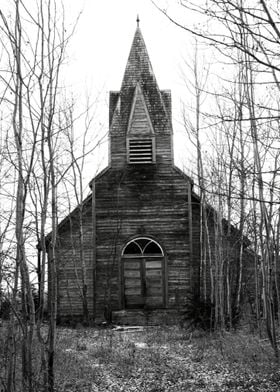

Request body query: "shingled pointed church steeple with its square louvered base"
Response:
[110, 24, 173, 166]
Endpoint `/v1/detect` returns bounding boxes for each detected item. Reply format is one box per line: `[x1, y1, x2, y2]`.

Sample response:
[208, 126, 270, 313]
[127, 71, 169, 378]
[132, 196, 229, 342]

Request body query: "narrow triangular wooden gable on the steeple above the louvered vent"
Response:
[127, 83, 154, 136]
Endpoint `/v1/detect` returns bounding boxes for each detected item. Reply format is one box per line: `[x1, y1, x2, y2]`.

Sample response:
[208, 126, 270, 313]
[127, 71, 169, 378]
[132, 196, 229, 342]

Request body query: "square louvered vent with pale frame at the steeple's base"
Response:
[128, 138, 154, 164]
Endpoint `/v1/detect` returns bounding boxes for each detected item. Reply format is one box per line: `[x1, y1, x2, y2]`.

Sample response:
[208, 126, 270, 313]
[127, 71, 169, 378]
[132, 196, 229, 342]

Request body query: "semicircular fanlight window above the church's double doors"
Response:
[122, 237, 163, 256]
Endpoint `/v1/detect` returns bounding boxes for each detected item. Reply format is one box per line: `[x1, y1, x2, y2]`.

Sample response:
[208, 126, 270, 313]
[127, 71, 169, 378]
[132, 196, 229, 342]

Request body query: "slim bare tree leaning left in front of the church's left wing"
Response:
[58, 97, 102, 325]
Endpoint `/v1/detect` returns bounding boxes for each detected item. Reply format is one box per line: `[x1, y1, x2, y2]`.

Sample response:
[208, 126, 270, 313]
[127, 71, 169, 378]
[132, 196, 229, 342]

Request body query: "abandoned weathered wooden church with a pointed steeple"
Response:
[49, 26, 252, 322]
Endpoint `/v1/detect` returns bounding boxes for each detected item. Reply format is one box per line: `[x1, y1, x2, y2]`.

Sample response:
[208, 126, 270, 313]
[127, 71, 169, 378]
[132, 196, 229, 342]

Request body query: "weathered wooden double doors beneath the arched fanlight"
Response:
[122, 255, 164, 309]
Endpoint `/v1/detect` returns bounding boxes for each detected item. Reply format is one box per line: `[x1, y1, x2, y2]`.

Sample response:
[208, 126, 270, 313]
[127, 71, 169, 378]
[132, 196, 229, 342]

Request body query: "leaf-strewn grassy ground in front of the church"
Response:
[56, 327, 280, 392]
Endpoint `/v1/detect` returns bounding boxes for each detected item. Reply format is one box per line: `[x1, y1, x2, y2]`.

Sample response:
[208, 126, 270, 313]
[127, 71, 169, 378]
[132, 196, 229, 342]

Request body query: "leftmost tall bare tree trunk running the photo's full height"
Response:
[4, 0, 35, 391]
